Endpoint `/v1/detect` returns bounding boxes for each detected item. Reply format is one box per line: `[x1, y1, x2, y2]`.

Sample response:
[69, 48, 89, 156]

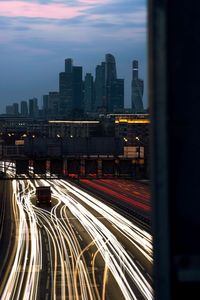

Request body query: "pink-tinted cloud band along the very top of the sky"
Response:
[0, 0, 146, 22]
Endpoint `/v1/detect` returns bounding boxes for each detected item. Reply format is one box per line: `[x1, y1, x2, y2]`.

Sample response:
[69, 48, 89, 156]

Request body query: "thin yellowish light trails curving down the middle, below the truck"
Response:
[27, 180, 95, 299]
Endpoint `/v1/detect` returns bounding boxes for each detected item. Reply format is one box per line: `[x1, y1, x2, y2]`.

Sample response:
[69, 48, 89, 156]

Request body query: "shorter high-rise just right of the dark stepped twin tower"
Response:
[84, 73, 94, 112]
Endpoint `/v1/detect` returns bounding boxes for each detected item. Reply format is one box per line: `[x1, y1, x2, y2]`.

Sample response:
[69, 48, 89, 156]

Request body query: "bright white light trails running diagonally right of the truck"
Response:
[43, 180, 153, 299]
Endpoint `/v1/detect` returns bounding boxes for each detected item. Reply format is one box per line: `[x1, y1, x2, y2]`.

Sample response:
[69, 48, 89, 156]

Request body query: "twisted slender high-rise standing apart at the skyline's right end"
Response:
[131, 60, 144, 113]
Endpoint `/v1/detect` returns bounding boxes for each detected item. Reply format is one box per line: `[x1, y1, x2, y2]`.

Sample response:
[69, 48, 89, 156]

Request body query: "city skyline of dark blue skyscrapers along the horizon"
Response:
[5, 53, 145, 118]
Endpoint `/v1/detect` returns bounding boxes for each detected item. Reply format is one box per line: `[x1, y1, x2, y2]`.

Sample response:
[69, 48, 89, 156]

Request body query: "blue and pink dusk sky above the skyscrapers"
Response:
[0, 0, 147, 113]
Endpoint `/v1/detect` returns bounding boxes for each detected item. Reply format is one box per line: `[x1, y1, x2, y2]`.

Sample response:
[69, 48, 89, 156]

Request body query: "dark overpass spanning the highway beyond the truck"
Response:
[0, 137, 145, 179]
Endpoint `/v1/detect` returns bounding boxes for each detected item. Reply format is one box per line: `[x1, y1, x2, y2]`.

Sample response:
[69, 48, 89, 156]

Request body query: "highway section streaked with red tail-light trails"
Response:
[79, 179, 151, 224]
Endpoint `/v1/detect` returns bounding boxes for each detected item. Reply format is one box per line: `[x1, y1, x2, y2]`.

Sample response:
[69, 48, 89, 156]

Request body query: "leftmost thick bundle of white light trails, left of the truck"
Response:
[1, 180, 41, 300]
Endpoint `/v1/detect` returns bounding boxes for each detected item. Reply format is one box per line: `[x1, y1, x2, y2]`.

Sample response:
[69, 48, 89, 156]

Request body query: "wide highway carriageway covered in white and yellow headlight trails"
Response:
[0, 179, 153, 300]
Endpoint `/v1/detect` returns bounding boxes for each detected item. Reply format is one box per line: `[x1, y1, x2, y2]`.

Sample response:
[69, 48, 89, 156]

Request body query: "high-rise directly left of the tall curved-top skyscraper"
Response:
[94, 62, 106, 111]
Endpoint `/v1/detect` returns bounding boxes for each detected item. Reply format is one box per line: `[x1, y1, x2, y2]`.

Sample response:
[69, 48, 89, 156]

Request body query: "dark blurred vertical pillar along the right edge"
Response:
[149, 0, 200, 300]
